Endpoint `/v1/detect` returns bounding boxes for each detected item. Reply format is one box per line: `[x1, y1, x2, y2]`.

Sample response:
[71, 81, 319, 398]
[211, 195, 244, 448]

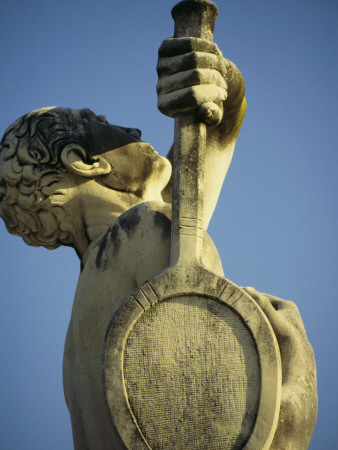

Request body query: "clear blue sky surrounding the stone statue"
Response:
[0, 0, 338, 450]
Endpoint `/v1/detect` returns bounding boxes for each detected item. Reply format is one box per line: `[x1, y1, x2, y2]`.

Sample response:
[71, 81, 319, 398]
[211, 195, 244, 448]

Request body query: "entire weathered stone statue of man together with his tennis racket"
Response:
[0, 0, 317, 450]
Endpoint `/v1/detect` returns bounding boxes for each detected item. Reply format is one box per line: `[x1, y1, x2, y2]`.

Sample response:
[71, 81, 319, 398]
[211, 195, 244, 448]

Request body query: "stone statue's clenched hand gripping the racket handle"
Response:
[157, 38, 244, 124]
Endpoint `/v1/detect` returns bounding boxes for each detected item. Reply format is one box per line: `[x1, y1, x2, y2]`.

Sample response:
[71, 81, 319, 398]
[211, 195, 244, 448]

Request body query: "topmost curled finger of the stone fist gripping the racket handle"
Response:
[158, 38, 221, 58]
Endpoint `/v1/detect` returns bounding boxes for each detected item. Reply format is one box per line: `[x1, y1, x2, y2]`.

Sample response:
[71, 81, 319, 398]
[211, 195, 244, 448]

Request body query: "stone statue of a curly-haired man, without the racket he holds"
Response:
[0, 34, 317, 450]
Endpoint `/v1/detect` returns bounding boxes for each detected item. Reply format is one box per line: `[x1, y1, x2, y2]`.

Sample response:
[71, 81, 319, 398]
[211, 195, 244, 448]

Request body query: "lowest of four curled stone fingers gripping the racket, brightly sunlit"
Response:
[157, 85, 226, 117]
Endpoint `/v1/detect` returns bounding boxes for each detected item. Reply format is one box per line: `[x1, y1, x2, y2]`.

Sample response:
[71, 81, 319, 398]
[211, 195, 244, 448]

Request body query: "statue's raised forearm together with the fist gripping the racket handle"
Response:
[157, 34, 246, 227]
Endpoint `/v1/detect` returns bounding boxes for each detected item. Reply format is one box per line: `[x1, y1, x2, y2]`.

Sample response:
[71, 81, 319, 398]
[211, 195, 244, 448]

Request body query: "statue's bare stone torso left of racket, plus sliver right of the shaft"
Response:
[64, 202, 222, 450]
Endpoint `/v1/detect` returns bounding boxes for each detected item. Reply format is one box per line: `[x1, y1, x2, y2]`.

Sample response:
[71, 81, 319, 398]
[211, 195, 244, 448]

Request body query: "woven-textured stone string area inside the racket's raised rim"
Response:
[124, 296, 261, 449]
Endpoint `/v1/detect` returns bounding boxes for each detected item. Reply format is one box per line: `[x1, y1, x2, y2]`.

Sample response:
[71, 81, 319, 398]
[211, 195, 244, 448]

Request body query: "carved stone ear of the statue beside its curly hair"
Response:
[61, 144, 111, 178]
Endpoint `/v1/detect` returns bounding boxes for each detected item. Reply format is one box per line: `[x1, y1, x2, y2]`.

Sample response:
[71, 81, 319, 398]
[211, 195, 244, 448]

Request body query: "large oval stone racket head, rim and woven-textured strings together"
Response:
[105, 266, 281, 449]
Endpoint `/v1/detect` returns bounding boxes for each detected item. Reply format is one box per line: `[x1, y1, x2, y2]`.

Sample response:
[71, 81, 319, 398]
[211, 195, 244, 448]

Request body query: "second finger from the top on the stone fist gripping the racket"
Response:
[157, 52, 222, 77]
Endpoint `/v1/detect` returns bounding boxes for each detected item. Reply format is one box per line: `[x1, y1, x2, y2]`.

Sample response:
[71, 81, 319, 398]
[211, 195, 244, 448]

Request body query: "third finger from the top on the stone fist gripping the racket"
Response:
[156, 69, 227, 95]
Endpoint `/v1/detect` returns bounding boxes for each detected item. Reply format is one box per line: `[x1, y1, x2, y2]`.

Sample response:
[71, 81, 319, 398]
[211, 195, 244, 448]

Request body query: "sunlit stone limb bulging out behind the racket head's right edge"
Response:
[244, 287, 317, 450]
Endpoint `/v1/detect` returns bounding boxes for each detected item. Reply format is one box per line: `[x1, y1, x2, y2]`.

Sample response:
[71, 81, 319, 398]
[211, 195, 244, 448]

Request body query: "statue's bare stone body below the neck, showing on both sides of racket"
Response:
[64, 202, 317, 450]
